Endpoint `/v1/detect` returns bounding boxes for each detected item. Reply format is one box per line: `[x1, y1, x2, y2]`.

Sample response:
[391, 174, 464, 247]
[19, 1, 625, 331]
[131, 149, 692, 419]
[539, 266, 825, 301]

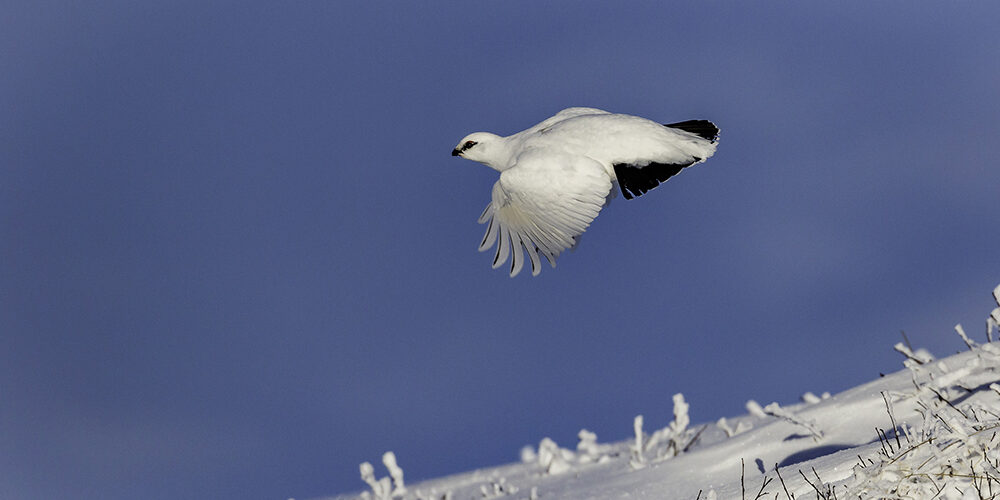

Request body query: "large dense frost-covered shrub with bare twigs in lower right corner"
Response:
[844, 292, 1000, 500]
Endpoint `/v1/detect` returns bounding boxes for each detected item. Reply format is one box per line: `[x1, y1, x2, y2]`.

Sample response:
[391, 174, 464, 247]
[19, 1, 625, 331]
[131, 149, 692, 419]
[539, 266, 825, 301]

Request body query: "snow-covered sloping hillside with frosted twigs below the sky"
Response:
[335, 286, 1000, 500]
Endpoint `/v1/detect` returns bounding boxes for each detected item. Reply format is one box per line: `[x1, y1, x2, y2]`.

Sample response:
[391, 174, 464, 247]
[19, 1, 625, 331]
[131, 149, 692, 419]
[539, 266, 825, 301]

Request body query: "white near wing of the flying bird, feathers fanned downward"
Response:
[479, 152, 611, 277]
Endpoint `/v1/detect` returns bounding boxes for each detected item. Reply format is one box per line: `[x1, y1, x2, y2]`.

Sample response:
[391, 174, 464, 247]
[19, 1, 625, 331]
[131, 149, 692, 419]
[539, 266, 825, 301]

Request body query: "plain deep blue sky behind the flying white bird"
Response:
[0, 1, 1000, 499]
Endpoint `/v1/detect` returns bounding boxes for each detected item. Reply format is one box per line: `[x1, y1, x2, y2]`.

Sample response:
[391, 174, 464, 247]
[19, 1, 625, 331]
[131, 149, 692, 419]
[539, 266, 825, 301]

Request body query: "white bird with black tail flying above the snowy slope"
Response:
[451, 108, 719, 277]
